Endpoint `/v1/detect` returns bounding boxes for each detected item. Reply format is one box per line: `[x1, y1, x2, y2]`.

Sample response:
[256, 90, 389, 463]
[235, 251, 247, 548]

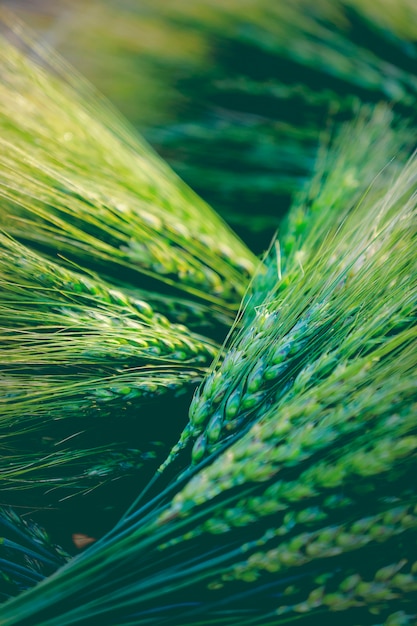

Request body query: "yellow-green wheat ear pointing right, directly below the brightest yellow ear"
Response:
[0, 235, 218, 368]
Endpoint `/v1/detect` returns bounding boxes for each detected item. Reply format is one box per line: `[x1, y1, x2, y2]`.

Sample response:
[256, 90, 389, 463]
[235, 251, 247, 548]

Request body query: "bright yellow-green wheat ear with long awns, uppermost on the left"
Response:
[0, 16, 257, 320]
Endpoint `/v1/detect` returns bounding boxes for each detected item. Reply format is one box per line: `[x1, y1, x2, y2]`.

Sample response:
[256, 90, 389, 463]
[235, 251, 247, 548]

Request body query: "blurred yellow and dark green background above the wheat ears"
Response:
[0, 0, 417, 253]
